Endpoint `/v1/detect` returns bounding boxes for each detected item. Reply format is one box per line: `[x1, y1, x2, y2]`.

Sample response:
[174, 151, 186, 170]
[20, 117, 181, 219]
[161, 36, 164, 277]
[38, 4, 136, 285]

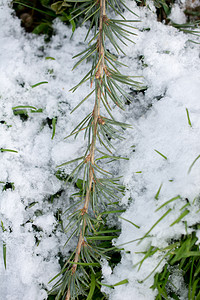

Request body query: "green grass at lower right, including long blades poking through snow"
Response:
[131, 191, 200, 300]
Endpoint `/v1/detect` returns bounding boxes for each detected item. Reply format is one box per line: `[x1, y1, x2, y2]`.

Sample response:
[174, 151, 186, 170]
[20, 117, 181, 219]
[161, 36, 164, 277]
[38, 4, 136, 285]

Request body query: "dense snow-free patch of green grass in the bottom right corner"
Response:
[151, 232, 200, 300]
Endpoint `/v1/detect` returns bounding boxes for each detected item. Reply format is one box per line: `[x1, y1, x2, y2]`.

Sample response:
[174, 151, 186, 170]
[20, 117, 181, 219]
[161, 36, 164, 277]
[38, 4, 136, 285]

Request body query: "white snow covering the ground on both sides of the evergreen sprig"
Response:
[0, 0, 200, 300]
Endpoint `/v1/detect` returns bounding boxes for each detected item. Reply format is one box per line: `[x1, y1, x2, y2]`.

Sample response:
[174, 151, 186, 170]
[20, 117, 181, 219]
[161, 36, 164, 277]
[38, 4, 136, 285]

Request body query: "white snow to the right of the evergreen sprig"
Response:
[101, 2, 200, 300]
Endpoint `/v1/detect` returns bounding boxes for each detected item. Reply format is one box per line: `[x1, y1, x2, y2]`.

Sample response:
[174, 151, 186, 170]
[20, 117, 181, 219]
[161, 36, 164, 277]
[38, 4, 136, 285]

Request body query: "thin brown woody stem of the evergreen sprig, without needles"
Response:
[65, 0, 106, 300]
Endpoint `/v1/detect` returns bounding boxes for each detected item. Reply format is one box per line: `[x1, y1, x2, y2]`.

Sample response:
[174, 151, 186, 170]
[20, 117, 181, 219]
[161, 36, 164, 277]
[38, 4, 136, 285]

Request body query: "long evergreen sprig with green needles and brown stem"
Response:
[49, 0, 139, 300]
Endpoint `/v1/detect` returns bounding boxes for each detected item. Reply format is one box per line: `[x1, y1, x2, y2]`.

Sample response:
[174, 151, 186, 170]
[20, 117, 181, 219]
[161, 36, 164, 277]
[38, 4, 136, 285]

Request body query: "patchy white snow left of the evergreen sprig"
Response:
[0, 1, 87, 300]
